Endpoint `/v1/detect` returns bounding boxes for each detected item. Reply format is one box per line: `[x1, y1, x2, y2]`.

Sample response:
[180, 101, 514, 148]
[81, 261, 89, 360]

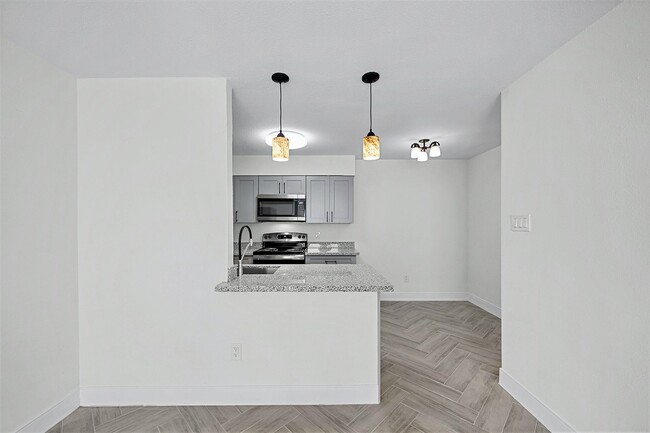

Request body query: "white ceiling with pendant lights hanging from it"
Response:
[2, 1, 618, 159]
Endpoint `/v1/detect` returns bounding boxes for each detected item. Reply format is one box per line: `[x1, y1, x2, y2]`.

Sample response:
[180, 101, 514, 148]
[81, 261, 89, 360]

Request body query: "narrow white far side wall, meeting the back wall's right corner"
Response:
[467, 147, 501, 308]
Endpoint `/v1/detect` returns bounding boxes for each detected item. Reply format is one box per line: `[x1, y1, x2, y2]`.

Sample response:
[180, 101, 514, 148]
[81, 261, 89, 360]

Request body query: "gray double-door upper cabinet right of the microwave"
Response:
[307, 176, 354, 224]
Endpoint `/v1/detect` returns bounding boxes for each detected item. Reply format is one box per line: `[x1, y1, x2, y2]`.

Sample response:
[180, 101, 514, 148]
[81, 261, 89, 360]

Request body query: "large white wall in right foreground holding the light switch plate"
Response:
[501, 2, 650, 431]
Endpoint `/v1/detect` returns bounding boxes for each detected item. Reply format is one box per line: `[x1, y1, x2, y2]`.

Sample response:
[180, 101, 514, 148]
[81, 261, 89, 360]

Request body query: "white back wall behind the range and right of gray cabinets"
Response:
[235, 157, 467, 293]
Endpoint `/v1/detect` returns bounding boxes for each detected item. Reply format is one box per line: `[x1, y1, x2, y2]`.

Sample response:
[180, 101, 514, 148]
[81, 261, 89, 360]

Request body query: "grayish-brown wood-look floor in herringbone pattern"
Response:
[48, 302, 548, 433]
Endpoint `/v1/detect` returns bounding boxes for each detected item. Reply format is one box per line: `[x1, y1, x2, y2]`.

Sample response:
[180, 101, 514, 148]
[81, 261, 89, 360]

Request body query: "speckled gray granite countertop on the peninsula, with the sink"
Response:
[215, 265, 393, 292]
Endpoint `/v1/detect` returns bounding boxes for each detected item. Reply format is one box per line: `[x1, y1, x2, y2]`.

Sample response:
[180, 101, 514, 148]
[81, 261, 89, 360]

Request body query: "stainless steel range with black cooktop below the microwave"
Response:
[253, 232, 307, 264]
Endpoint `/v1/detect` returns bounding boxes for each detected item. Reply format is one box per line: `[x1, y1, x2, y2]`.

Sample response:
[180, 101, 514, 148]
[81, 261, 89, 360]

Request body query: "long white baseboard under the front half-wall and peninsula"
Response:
[81, 385, 379, 406]
